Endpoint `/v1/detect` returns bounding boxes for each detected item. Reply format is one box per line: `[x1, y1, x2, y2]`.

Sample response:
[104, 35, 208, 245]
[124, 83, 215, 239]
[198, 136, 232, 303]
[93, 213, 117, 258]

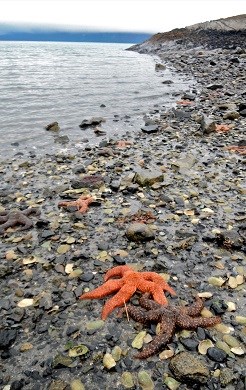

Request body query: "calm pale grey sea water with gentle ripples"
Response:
[0, 42, 190, 158]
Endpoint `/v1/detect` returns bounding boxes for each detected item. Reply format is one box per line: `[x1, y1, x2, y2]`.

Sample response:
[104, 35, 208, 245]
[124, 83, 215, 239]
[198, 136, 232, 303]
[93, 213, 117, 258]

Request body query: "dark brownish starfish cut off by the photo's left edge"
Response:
[0, 207, 40, 234]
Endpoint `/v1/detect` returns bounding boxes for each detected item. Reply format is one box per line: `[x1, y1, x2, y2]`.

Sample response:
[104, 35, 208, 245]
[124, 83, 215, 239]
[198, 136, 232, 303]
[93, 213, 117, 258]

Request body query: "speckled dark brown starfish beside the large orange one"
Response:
[127, 294, 221, 359]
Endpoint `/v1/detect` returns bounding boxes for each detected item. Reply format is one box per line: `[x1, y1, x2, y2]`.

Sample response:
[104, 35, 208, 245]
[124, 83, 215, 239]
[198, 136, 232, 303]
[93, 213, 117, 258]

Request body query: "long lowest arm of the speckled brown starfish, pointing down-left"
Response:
[135, 318, 175, 359]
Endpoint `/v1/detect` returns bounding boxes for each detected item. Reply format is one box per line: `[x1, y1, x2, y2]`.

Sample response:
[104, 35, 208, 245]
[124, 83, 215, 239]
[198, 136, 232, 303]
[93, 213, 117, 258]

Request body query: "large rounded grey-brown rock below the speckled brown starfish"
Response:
[169, 352, 210, 384]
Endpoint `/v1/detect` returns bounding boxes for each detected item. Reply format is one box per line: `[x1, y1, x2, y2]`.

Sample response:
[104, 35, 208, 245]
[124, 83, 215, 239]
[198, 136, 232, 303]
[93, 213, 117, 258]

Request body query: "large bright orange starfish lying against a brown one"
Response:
[79, 265, 176, 320]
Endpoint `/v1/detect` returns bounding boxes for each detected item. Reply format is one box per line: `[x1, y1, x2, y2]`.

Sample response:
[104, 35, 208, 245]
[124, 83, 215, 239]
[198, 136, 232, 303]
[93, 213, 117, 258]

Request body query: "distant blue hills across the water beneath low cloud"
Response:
[0, 24, 151, 43]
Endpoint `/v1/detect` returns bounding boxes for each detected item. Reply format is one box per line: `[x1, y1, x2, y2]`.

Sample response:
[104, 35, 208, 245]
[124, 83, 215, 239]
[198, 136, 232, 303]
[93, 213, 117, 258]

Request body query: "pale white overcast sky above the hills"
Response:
[0, 0, 246, 33]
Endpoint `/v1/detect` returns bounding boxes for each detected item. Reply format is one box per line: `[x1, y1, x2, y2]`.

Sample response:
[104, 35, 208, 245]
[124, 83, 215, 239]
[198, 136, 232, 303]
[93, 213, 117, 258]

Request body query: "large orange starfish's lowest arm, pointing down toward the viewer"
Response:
[102, 281, 136, 320]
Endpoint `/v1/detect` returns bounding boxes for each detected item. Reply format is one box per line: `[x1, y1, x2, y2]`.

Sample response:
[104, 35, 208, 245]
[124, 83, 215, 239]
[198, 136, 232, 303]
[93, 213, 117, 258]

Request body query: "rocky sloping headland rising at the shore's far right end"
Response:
[130, 14, 246, 52]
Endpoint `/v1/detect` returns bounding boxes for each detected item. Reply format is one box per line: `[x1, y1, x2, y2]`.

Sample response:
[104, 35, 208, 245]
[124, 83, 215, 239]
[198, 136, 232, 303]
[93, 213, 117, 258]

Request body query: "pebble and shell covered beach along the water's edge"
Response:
[0, 38, 246, 390]
